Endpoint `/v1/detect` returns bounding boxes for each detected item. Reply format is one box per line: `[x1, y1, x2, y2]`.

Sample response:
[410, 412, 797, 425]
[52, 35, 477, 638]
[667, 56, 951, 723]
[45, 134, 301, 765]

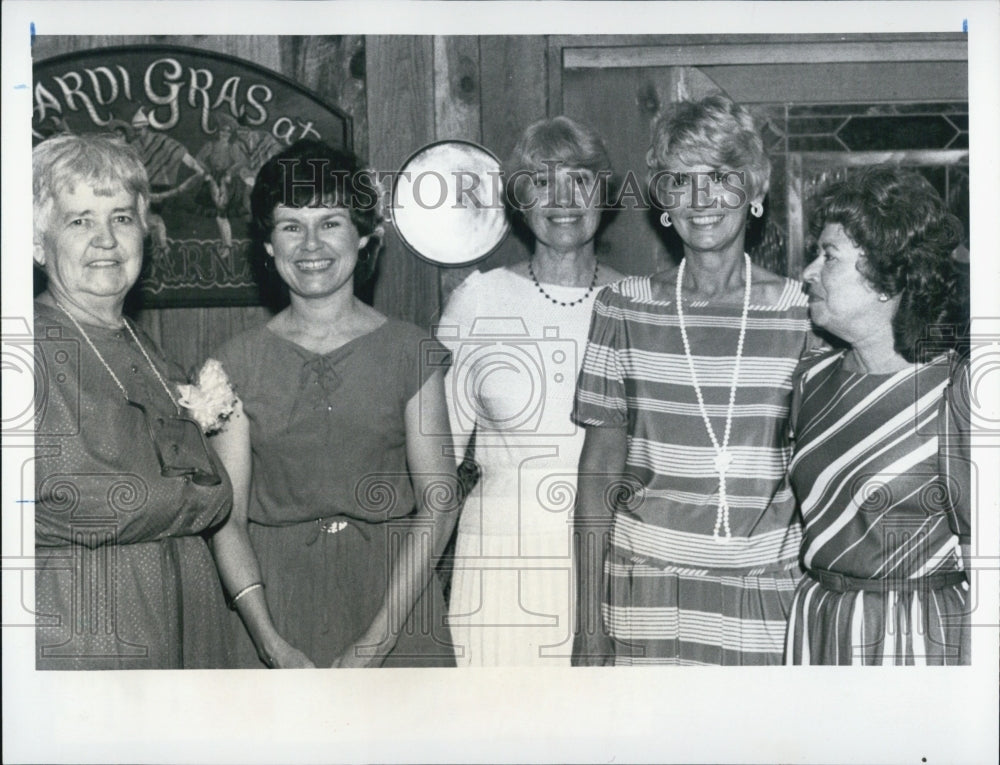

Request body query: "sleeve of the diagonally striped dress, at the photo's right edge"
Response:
[938, 360, 973, 545]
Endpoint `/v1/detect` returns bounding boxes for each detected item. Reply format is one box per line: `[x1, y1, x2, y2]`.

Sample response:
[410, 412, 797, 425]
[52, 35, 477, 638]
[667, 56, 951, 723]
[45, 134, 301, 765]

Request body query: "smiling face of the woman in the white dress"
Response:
[524, 165, 601, 252]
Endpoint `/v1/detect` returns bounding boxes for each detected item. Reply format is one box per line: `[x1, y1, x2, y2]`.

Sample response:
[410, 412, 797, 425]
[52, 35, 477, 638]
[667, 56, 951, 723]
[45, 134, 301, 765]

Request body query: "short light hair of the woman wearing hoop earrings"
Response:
[646, 94, 771, 203]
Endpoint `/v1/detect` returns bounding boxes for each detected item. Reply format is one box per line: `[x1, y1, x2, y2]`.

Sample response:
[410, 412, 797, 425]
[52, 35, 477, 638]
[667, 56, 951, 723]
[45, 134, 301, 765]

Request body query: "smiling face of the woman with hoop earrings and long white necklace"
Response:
[658, 159, 763, 254]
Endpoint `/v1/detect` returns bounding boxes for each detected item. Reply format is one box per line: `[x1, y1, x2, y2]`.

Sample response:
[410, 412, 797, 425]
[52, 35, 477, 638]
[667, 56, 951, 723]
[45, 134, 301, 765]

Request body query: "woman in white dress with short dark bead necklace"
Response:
[438, 117, 621, 666]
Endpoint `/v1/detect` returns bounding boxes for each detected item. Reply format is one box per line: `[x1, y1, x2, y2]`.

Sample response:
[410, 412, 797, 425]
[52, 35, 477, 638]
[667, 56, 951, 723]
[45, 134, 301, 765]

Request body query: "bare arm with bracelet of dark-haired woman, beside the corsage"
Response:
[210, 402, 315, 669]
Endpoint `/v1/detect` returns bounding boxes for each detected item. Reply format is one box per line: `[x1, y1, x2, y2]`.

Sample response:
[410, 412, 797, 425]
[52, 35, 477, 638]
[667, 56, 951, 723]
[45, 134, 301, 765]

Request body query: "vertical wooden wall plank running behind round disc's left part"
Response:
[365, 35, 440, 326]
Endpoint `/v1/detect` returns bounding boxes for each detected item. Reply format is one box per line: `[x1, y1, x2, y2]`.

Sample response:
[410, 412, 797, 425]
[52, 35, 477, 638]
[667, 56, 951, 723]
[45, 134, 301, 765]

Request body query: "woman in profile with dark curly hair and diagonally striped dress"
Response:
[785, 168, 971, 664]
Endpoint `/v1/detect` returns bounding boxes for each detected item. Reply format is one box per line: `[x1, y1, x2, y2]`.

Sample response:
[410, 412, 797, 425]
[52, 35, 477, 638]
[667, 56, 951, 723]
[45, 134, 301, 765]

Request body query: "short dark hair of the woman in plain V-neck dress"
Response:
[250, 138, 383, 284]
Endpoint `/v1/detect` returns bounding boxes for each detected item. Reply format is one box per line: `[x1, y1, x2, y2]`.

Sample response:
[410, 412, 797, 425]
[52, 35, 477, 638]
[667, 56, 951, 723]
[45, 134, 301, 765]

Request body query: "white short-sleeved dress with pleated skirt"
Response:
[438, 268, 599, 666]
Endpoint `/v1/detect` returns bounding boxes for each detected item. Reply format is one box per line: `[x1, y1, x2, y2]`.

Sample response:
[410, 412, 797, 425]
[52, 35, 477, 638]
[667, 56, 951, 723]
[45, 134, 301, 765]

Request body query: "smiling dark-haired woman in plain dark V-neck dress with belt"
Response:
[213, 141, 457, 667]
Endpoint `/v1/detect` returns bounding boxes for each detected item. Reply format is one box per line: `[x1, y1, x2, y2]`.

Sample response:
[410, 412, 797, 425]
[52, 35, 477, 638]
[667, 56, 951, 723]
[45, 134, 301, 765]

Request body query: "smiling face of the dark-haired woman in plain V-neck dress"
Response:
[264, 205, 368, 298]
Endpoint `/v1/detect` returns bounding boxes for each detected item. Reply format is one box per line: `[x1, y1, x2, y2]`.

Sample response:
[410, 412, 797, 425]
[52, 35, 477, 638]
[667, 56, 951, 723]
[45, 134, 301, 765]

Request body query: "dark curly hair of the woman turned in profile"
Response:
[810, 167, 968, 363]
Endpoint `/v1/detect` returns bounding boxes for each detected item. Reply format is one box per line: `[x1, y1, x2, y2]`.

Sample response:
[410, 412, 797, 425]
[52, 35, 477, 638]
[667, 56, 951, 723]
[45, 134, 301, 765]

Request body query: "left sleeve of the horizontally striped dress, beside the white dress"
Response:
[572, 285, 628, 428]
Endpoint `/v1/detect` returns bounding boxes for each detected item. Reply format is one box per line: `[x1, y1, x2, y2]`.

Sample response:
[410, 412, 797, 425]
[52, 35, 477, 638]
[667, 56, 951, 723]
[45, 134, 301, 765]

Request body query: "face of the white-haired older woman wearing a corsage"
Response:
[34, 182, 144, 313]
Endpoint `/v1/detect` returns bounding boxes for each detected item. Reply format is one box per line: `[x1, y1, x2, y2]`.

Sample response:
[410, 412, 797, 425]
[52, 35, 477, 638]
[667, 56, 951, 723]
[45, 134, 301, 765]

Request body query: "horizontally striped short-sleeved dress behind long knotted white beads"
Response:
[574, 277, 809, 665]
